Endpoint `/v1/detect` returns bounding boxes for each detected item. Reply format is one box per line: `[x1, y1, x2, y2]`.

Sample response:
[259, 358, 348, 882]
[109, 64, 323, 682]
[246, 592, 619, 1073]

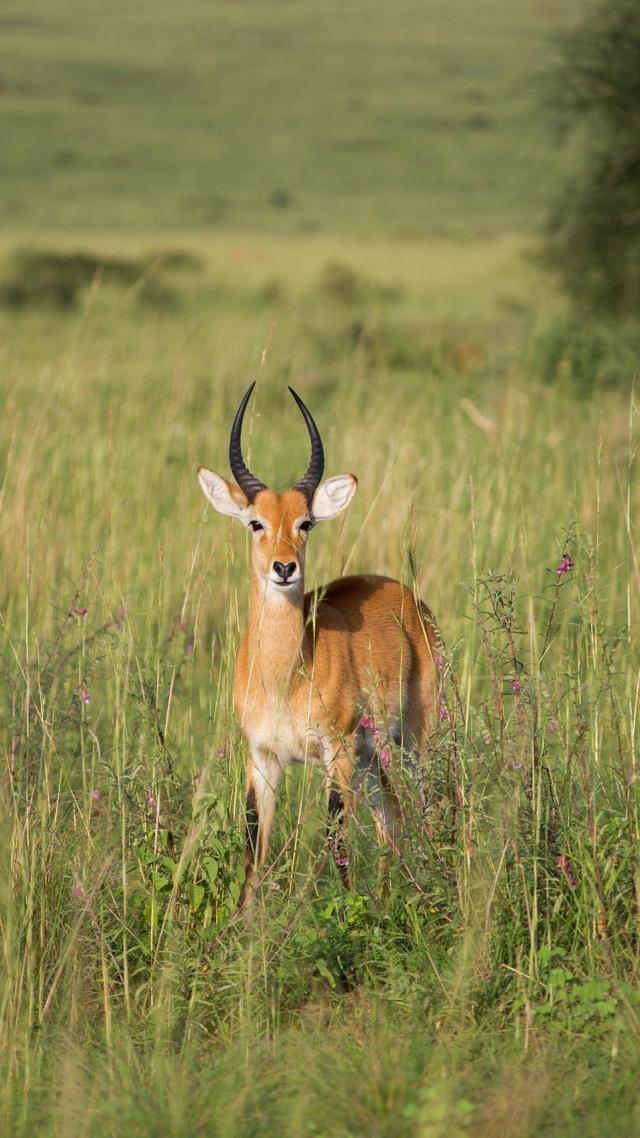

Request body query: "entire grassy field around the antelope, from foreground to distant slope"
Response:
[0, 0, 640, 1138]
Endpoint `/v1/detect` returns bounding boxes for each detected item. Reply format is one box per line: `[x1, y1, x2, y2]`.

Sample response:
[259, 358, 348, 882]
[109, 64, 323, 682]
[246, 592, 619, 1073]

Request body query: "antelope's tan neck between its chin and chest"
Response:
[247, 575, 304, 695]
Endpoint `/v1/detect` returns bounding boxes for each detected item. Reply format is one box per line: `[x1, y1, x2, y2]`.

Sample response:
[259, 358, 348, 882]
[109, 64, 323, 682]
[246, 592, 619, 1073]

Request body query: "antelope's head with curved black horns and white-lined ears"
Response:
[198, 384, 358, 595]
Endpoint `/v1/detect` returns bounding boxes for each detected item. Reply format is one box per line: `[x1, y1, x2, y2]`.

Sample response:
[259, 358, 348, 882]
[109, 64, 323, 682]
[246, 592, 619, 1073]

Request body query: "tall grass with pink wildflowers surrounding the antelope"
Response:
[0, 270, 640, 1138]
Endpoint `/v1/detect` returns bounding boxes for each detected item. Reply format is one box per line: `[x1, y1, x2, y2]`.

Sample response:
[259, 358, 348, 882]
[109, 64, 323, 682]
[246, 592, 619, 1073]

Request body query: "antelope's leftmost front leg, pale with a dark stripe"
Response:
[239, 748, 282, 908]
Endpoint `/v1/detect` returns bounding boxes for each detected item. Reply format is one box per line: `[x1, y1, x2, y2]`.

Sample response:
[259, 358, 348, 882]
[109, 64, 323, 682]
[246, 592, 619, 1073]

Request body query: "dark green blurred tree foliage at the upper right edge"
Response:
[539, 0, 640, 315]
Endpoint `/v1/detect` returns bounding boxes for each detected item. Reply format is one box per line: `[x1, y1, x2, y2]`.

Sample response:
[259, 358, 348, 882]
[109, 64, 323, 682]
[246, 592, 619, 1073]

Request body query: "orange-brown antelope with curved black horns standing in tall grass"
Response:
[198, 382, 440, 908]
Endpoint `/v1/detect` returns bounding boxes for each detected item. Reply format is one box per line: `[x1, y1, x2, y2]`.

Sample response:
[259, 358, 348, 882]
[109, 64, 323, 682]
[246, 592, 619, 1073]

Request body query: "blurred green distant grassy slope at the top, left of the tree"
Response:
[0, 0, 574, 239]
